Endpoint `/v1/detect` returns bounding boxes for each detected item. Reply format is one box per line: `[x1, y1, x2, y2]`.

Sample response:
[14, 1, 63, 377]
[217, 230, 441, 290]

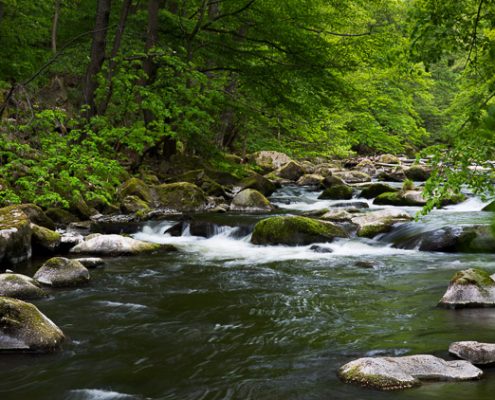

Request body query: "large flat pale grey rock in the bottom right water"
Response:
[338, 354, 483, 390]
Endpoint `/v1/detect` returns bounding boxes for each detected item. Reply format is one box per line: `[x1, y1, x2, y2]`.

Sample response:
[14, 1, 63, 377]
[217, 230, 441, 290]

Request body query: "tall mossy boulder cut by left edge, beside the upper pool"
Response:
[0, 206, 32, 265]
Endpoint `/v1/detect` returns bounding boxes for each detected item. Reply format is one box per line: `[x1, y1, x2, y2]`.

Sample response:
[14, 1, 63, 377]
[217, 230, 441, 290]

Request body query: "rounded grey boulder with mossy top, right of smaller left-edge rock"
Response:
[33, 257, 89, 287]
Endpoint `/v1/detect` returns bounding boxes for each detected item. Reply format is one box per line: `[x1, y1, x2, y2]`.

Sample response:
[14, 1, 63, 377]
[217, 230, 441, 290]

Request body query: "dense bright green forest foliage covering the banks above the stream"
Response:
[0, 0, 495, 207]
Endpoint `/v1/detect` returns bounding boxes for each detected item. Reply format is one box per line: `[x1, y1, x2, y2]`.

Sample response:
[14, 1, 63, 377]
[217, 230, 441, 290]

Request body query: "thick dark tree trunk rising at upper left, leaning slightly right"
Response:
[84, 0, 112, 118]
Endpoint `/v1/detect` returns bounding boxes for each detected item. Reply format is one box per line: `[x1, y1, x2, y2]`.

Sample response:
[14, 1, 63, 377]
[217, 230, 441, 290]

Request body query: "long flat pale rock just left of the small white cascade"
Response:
[71, 235, 165, 256]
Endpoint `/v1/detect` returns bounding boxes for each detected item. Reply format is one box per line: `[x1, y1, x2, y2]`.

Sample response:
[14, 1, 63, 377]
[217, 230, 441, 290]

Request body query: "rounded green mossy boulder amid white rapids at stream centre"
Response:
[251, 216, 347, 246]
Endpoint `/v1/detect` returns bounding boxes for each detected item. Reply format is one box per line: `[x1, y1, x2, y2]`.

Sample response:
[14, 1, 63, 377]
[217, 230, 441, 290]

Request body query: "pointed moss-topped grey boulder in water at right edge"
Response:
[438, 268, 495, 308]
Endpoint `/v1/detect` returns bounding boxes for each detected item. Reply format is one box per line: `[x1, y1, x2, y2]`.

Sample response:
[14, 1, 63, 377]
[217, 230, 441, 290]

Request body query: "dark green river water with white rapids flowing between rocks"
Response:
[0, 188, 495, 400]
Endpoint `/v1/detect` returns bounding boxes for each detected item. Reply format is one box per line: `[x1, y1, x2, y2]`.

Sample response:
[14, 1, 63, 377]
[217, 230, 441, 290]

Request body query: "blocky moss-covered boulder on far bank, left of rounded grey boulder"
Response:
[155, 182, 208, 212]
